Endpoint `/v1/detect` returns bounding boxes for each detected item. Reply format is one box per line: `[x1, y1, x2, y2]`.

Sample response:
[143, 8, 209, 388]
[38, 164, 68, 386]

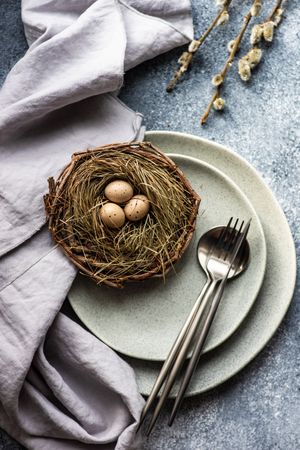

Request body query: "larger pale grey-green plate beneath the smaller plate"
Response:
[120, 131, 296, 395]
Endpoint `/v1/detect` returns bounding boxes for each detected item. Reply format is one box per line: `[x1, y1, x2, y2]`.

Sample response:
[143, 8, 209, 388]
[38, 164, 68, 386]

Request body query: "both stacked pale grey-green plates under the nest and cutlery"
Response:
[69, 132, 296, 395]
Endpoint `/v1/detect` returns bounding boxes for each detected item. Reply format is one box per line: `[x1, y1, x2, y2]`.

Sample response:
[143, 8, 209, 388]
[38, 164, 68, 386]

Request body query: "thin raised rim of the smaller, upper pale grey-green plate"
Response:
[68, 152, 268, 363]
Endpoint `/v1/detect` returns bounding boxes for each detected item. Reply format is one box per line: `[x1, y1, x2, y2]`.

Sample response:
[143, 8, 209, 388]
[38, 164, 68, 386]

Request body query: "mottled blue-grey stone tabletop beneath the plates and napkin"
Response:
[0, 0, 300, 450]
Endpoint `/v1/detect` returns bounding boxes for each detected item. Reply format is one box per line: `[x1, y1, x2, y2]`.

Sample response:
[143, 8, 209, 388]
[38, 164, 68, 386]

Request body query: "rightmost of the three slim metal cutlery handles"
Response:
[169, 278, 227, 426]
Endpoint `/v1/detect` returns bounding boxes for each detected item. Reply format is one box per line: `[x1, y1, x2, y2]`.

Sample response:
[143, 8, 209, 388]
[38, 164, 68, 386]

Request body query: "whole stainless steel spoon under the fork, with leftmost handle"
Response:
[139, 219, 250, 427]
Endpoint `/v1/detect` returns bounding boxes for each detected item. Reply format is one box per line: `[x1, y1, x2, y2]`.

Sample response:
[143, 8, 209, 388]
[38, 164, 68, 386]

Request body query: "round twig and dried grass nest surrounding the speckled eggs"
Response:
[44, 142, 200, 287]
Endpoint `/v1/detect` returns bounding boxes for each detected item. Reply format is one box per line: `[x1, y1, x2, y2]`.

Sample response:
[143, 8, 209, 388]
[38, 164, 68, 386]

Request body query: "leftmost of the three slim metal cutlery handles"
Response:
[139, 278, 212, 427]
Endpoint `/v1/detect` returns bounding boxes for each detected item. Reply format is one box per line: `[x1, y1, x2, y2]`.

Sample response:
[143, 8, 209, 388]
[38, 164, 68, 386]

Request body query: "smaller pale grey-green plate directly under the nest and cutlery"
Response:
[69, 154, 266, 361]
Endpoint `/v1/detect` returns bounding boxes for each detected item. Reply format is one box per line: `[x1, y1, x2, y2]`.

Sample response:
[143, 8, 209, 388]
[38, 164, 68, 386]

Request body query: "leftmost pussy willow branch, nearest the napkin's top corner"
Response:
[166, 0, 232, 92]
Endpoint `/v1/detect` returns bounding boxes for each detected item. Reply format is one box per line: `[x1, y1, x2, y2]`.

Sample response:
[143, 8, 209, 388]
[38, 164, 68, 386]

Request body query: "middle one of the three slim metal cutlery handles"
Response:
[146, 280, 219, 436]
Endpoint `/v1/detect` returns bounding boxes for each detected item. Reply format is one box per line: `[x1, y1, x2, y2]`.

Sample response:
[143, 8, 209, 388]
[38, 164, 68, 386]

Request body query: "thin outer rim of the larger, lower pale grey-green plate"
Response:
[126, 130, 297, 397]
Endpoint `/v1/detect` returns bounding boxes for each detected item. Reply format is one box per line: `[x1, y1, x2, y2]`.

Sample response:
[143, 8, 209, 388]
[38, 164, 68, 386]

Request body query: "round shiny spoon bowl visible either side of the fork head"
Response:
[197, 226, 250, 278]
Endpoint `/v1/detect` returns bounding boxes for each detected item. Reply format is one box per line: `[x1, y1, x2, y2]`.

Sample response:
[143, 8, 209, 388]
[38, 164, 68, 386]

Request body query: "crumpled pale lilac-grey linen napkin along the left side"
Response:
[0, 0, 192, 450]
